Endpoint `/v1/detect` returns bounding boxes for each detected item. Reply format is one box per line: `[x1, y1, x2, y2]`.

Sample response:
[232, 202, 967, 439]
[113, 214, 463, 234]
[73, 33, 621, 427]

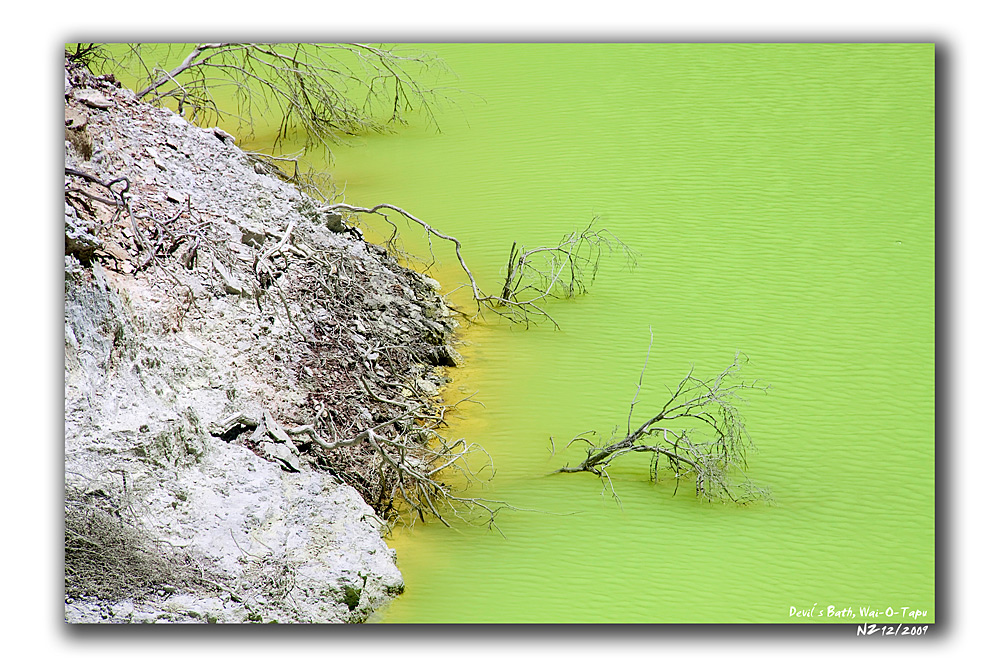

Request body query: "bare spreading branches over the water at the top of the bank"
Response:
[78, 42, 445, 151]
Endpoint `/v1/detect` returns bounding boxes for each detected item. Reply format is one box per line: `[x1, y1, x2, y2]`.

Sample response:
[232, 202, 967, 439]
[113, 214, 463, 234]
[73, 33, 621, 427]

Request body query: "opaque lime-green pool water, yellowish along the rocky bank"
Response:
[97, 44, 934, 623]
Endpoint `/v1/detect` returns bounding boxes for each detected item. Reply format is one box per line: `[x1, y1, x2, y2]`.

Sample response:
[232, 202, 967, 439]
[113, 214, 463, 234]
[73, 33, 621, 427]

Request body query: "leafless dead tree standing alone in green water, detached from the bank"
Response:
[554, 352, 770, 504]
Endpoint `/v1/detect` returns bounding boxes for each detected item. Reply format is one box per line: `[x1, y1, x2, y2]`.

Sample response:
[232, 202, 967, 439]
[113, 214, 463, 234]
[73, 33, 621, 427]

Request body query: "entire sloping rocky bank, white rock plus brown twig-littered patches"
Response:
[65, 63, 456, 623]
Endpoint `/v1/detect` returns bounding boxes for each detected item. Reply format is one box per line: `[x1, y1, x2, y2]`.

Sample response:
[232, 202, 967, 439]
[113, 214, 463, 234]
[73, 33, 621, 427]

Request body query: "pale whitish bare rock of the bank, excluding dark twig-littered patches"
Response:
[65, 60, 454, 623]
